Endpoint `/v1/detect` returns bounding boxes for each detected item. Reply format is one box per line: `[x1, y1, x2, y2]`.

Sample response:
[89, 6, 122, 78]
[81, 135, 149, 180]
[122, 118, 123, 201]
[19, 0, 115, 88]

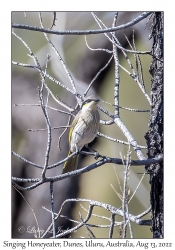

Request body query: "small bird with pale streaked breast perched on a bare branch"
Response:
[62, 95, 100, 174]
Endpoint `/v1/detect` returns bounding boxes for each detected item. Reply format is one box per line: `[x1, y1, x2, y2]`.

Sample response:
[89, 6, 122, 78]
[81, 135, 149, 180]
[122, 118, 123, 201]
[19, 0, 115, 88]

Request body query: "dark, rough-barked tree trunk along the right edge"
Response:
[145, 12, 163, 238]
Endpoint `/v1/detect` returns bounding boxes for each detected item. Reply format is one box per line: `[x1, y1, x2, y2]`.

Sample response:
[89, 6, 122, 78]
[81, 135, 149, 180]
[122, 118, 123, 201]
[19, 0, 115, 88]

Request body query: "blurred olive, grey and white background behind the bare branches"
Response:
[11, 12, 152, 238]
